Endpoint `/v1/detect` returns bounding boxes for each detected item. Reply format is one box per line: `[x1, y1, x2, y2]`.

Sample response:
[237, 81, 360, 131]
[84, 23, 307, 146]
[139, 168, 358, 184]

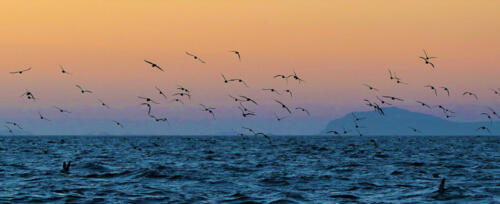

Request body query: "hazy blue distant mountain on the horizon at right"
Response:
[322, 107, 500, 136]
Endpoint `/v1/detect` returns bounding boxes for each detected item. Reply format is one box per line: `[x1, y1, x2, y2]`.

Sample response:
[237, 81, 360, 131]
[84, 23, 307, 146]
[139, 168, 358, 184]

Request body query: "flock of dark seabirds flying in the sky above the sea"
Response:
[1, 50, 500, 139]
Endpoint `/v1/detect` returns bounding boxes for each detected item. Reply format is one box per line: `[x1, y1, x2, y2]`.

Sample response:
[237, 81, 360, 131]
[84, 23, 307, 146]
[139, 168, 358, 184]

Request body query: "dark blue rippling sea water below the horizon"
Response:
[0, 136, 500, 203]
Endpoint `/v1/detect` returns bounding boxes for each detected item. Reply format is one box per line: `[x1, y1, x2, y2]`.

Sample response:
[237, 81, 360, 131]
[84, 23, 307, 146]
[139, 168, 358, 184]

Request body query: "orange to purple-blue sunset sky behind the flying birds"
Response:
[0, 0, 500, 134]
